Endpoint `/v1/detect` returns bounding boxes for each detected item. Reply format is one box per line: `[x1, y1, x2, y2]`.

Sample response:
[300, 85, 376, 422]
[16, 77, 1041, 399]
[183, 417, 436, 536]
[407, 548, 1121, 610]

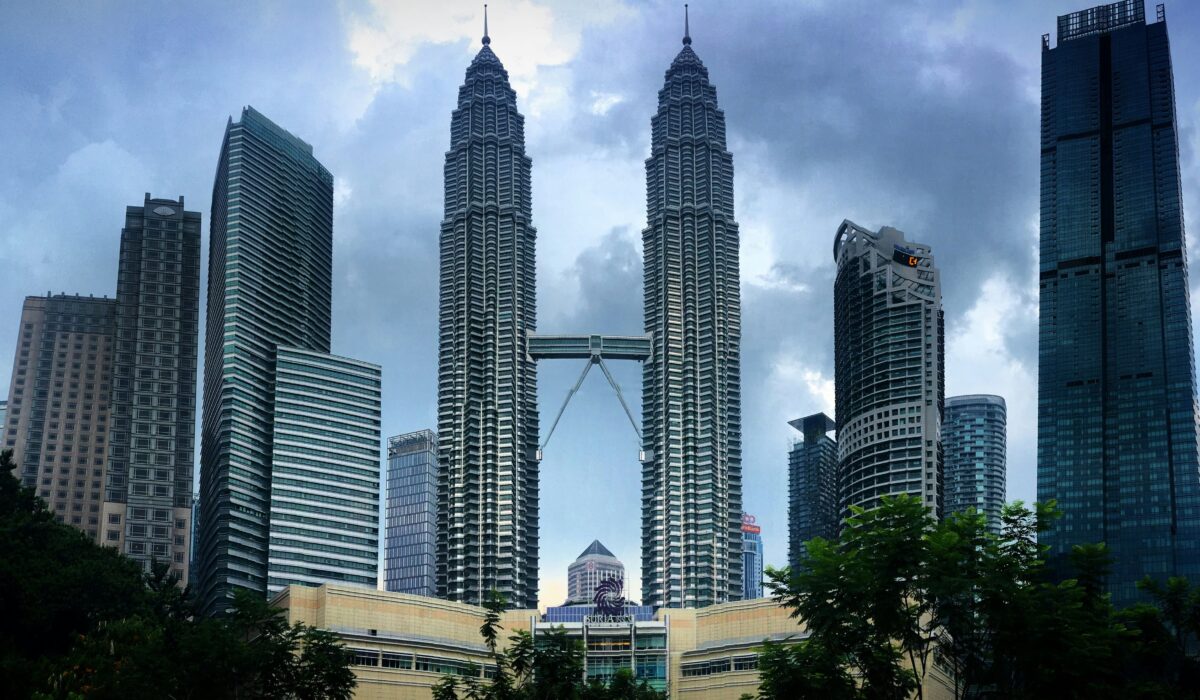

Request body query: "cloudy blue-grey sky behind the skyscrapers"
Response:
[0, 0, 1200, 604]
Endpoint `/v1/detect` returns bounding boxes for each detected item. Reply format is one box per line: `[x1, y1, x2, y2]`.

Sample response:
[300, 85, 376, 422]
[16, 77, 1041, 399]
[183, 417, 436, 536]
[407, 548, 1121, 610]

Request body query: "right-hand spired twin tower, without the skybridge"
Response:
[642, 15, 742, 608]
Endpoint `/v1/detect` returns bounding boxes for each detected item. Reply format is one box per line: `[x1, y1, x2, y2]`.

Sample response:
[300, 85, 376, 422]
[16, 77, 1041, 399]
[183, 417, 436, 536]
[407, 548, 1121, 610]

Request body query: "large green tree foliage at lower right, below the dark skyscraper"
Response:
[758, 496, 1200, 700]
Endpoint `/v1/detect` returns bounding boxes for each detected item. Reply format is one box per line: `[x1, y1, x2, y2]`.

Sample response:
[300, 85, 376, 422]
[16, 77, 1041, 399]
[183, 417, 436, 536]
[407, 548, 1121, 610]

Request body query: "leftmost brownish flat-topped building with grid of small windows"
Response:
[5, 294, 116, 544]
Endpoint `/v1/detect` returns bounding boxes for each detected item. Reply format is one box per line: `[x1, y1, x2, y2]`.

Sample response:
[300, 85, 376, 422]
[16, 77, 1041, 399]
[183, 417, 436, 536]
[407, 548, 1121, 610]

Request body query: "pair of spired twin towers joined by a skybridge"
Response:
[438, 17, 742, 609]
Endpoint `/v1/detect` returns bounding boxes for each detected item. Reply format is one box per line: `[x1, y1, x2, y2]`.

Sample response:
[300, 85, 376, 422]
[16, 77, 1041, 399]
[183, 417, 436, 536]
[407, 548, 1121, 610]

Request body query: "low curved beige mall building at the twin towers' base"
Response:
[274, 584, 953, 700]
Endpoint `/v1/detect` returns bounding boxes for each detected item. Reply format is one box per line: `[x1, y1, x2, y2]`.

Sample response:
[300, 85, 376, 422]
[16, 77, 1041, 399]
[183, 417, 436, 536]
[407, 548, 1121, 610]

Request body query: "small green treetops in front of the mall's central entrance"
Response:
[433, 591, 666, 700]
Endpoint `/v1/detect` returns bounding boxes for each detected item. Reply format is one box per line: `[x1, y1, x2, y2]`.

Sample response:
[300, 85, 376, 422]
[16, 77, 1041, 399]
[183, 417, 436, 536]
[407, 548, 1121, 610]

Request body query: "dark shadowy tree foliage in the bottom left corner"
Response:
[0, 450, 355, 700]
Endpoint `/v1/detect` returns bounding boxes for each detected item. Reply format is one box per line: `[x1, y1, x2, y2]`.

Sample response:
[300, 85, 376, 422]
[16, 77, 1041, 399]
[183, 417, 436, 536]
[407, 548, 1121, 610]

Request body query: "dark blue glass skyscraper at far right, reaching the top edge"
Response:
[1038, 0, 1200, 605]
